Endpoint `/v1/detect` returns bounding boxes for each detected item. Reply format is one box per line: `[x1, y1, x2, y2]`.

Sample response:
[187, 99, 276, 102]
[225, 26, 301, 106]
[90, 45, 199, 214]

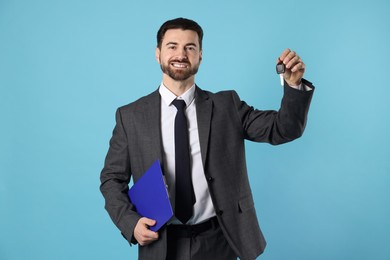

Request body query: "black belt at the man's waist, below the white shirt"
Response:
[167, 217, 218, 238]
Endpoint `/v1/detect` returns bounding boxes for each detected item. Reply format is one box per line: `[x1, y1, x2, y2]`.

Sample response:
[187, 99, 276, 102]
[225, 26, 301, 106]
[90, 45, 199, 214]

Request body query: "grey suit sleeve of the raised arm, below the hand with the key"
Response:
[233, 80, 314, 145]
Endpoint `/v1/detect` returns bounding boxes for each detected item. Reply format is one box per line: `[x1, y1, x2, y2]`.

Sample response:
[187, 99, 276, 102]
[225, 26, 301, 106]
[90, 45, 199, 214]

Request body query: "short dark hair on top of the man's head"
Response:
[157, 18, 203, 49]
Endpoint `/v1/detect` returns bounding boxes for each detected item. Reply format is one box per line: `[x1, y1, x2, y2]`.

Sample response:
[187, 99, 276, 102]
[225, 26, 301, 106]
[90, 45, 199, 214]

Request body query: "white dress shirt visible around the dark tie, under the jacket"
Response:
[159, 83, 215, 225]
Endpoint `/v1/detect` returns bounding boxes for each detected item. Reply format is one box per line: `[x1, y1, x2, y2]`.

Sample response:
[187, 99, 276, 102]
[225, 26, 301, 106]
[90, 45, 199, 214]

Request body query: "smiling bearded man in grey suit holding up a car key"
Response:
[100, 18, 314, 260]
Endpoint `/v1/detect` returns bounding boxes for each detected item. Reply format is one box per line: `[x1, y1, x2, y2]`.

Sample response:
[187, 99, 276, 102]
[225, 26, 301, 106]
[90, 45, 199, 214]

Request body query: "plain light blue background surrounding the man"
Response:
[0, 0, 390, 260]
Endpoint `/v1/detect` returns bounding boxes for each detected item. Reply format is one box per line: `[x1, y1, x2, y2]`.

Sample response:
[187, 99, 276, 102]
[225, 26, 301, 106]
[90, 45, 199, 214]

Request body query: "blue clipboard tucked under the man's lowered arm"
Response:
[128, 160, 173, 232]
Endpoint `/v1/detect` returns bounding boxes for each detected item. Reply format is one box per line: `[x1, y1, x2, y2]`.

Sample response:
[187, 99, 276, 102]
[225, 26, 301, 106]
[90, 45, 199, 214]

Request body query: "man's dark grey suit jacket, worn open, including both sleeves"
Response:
[100, 81, 314, 260]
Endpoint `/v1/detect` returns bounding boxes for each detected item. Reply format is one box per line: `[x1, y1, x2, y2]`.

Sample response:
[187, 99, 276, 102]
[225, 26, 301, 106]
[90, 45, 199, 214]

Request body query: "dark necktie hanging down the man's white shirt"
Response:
[172, 100, 195, 224]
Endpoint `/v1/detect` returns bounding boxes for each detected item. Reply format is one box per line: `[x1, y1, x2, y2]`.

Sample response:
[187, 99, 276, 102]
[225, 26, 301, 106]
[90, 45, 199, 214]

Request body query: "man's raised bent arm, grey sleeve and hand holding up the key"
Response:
[233, 49, 314, 145]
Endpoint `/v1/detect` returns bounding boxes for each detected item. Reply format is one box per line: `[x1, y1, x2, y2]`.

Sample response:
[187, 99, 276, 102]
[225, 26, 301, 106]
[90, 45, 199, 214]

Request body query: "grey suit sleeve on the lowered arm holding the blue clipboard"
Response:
[100, 109, 141, 243]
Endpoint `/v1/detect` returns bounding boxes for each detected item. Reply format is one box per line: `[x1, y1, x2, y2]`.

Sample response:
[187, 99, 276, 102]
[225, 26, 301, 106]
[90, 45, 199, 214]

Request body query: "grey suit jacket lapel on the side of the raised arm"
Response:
[195, 86, 213, 167]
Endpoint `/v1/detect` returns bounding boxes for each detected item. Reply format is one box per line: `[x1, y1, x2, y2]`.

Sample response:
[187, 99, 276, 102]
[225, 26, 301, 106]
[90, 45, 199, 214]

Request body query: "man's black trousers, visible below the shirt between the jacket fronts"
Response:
[166, 218, 237, 260]
